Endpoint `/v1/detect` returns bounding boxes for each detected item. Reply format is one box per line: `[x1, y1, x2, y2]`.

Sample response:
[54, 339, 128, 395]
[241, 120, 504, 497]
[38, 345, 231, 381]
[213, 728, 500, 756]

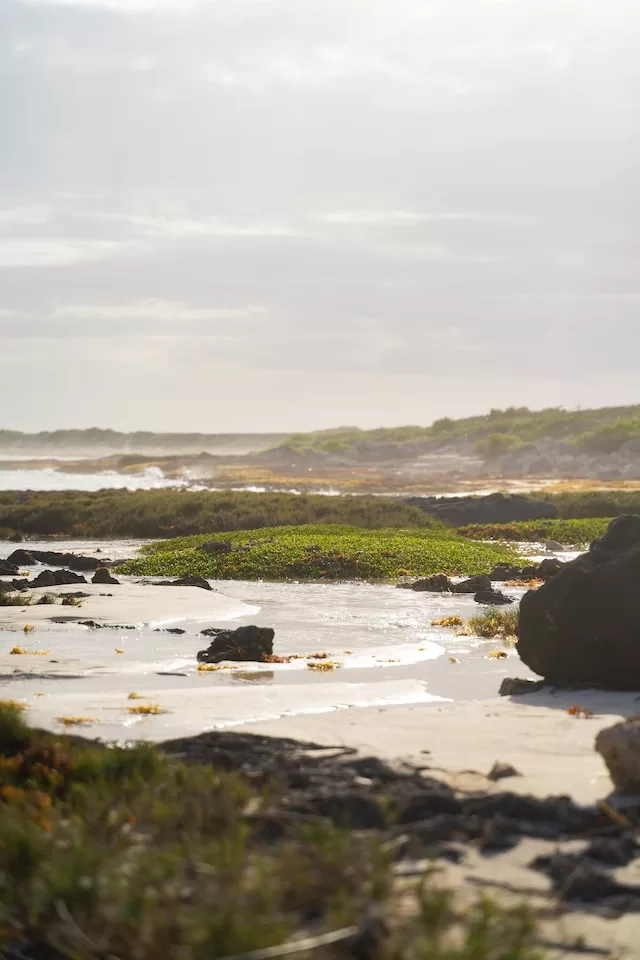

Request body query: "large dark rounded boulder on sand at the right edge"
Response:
[517, 516, 640, 690]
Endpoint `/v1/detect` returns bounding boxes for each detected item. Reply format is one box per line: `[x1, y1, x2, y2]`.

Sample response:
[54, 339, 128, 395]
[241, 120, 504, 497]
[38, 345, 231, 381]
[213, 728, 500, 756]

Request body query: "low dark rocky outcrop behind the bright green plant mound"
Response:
[407, 493, 558, 527]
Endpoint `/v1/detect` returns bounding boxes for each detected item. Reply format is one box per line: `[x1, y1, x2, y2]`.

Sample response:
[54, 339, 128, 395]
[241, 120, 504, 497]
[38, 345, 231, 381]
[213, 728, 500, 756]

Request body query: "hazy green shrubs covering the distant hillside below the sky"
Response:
[272, 405, 640, 458]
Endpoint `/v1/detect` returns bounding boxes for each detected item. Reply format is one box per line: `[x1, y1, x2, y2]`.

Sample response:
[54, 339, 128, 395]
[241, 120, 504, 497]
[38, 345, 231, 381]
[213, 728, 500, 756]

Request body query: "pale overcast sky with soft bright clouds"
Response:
[0, 0, 640, 432]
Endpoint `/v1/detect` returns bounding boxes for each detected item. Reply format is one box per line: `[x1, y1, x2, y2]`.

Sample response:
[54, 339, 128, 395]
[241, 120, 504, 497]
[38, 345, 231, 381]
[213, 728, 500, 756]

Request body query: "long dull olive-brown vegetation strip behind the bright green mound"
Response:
[0, 490, 437, 538]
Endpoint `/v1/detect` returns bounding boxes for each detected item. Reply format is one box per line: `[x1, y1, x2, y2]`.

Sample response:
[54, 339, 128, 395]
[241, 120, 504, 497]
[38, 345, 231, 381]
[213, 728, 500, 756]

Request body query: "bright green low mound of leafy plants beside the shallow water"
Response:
[119, 526, 516, 581]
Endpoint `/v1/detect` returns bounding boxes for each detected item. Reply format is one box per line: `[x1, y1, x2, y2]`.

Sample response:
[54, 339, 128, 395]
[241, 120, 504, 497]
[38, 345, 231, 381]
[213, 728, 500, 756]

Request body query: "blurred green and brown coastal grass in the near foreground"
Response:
[0, 703, 541, 960]
